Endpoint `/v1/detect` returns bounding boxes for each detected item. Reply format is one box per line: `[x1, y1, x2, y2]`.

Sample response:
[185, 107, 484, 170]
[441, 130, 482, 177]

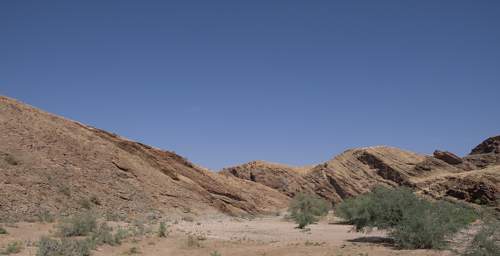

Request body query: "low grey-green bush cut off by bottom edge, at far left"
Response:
[36, 237, 92, 256]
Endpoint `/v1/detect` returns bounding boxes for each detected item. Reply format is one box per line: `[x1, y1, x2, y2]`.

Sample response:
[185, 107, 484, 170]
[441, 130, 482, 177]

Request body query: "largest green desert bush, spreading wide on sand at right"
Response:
[335, 187, 478, 249]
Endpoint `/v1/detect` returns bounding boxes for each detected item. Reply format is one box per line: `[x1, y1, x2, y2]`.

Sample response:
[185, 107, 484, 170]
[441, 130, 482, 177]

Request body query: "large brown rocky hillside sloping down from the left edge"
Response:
[0, 97, 288, 222]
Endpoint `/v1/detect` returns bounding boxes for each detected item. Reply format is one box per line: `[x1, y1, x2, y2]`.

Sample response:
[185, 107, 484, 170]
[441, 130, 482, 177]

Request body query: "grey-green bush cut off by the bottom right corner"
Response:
[463, 218, 500, 256]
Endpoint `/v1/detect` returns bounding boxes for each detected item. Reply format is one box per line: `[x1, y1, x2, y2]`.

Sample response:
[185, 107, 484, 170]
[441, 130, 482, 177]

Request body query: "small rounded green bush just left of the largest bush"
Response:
[288, 193, 329, 229]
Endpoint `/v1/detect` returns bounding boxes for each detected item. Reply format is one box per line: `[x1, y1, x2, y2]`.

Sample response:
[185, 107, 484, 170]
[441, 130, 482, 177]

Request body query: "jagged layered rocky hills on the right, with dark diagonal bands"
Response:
[223, 141, 500, 208]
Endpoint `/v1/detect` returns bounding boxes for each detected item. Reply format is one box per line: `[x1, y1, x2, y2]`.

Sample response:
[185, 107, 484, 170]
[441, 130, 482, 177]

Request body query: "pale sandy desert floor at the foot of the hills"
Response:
[0, 216, 453, 256]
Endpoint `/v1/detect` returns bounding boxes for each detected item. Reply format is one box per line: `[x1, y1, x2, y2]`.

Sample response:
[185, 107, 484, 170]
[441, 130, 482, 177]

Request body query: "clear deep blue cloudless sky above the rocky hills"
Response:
[0, 0, 500, 169]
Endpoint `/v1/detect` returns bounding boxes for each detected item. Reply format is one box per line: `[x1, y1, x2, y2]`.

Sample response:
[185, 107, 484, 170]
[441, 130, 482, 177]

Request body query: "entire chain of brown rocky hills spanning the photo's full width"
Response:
[0, 96, 500, 220]
